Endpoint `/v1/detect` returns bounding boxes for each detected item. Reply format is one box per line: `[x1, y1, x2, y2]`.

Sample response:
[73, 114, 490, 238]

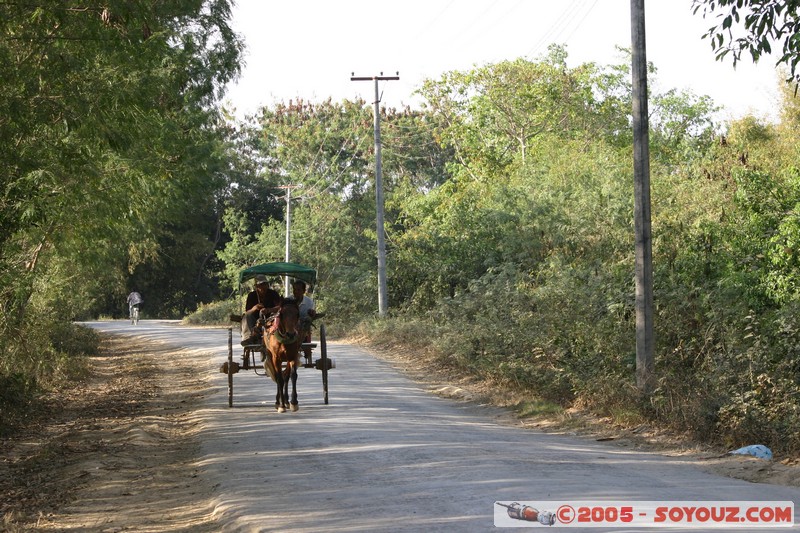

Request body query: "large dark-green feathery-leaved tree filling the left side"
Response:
[0, 0, 242, 373]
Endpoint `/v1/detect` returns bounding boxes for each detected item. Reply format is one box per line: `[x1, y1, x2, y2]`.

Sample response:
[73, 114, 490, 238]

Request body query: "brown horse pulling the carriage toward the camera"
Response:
[264, 300, 302, 413]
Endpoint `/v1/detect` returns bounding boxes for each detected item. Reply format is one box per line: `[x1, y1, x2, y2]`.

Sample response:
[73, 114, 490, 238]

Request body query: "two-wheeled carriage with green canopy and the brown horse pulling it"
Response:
[225, 263, 335, 412]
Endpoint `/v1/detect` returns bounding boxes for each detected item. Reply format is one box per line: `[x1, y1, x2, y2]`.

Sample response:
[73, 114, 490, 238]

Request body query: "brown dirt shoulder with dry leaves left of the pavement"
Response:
[0, 337, 216, 532]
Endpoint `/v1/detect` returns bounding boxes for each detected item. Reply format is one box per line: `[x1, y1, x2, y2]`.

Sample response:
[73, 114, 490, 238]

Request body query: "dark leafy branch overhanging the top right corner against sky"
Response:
[692, 0, 800, 83]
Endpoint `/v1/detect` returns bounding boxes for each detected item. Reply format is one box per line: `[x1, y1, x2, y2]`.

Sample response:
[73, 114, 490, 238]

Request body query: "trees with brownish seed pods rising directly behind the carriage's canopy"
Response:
[218, 100, 454, 319]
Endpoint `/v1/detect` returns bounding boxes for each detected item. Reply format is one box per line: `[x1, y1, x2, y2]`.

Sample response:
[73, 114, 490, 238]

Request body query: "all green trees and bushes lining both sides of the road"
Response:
[0, 2, 800, 456]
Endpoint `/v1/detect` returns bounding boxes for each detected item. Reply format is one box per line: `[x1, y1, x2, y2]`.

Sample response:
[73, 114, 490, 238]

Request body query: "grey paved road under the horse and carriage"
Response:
[84, 321, 800, 532]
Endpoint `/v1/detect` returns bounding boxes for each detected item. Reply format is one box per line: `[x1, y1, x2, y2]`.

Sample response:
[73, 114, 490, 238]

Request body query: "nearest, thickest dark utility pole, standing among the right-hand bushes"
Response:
[631, 0, 655, 394]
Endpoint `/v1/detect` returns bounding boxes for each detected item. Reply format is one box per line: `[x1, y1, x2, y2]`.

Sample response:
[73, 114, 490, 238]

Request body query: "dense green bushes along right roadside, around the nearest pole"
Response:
[370, 115, 800, 454]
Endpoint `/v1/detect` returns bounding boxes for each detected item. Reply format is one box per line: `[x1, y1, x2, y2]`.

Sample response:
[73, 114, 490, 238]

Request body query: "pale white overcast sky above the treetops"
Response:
[226, 0, 780, 119]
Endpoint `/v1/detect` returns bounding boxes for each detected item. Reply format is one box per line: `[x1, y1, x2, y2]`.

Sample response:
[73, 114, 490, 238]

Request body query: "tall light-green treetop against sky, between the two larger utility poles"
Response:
[420, 45, 630, 179]
